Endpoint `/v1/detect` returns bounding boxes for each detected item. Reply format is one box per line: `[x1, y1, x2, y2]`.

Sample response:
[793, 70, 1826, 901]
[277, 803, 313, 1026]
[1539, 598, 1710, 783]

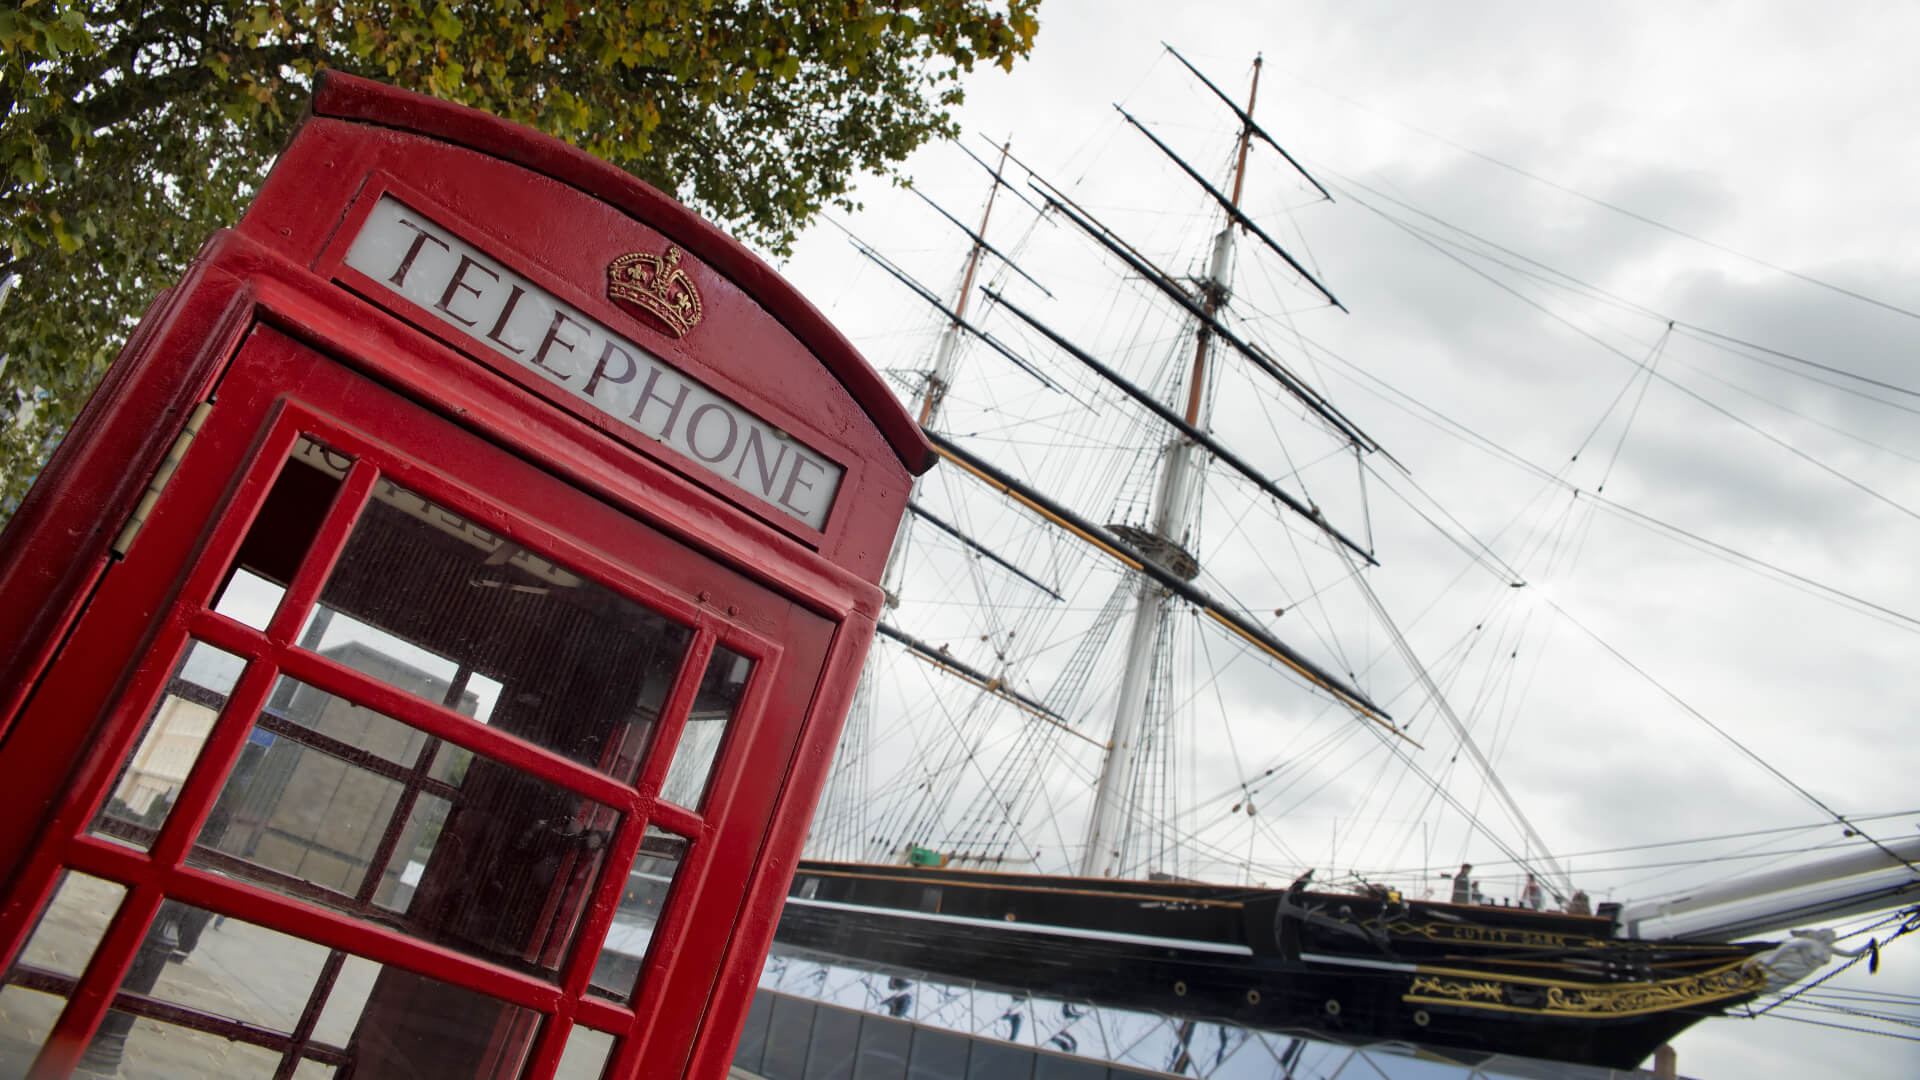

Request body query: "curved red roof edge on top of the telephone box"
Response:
[313, 71, 935, 475]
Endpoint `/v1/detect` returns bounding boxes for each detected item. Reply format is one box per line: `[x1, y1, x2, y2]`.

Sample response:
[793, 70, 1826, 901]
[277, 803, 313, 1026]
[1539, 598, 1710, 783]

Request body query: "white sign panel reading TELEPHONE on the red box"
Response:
[346, 196, 847, 528]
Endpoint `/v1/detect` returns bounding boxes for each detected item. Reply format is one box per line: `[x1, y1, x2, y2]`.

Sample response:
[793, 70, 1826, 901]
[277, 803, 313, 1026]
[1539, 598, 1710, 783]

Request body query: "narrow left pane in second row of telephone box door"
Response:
[92, 642, 246, 851]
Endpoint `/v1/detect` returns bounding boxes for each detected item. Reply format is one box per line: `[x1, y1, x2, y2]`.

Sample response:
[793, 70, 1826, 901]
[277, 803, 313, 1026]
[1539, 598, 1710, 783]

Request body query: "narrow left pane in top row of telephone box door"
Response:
[213, 436, 353, 630]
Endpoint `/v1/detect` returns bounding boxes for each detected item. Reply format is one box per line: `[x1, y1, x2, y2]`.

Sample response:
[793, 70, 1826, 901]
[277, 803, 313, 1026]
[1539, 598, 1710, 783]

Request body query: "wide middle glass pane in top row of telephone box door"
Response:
[301, 479, 693, 780]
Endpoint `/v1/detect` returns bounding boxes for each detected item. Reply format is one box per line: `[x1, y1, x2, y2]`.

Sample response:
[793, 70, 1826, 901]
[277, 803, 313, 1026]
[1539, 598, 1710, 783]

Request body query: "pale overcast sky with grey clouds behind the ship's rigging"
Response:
[768, 0, 1920, 1078]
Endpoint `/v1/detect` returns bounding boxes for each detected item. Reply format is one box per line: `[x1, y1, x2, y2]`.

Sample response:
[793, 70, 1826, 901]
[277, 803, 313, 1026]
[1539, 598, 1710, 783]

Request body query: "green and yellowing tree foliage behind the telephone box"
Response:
[0, 0, 1039, 519]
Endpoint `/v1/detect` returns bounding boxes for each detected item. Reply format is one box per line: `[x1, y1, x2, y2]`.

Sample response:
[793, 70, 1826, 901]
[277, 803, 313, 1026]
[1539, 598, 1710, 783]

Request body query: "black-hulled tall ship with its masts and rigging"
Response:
[648, 50, 1920, 1068]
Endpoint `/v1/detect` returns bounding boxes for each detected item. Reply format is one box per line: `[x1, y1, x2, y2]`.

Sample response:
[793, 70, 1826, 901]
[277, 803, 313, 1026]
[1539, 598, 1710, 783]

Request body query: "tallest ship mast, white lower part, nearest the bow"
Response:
[1079, 56, 1261, 878]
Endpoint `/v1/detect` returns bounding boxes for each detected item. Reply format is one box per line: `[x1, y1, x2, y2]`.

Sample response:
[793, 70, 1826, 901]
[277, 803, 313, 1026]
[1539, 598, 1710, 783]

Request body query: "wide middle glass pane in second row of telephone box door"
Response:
[188, 676, 620, 980]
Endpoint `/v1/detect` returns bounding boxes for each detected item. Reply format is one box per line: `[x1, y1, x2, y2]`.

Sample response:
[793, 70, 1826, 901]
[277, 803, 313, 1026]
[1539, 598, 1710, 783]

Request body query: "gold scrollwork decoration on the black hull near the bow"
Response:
[1402, 961, 1766, 1017]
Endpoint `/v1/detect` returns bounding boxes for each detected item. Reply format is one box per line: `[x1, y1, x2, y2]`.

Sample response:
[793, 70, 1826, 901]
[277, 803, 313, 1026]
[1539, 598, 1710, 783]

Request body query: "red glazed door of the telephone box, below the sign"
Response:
[0, 325, 835, 1078]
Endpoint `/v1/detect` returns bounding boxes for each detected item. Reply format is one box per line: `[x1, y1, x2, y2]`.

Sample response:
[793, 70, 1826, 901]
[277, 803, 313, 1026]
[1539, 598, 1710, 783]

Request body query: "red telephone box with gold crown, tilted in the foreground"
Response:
[0, 75, 931, 1078]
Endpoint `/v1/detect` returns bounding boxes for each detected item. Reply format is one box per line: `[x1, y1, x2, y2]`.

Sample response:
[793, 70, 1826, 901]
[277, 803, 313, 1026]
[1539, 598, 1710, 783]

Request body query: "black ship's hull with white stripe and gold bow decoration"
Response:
[752, 863, 1759, 1068]
